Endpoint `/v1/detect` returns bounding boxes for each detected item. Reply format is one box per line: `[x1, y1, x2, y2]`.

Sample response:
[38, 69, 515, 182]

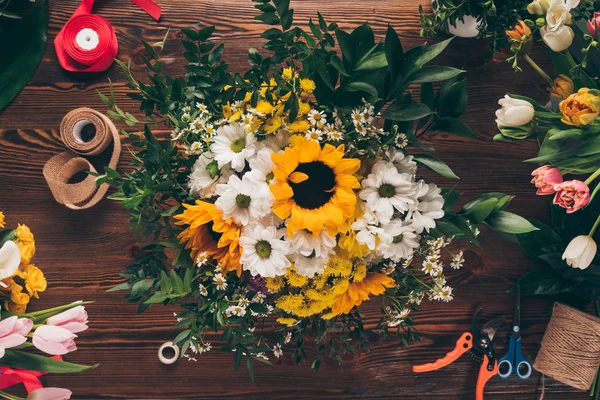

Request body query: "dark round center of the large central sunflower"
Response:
[288, 161, 335, 210]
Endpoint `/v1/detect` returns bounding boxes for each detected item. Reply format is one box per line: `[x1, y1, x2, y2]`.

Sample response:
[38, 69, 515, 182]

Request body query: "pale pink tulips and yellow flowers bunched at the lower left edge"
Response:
[0, 212, 96, 400]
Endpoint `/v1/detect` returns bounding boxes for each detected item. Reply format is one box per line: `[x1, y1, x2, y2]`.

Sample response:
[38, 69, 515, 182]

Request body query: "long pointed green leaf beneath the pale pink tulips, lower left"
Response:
[0, 349, 100, 374]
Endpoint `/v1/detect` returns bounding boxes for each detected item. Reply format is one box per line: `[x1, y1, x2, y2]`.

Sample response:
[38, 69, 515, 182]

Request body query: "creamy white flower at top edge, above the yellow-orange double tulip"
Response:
[540, 0, 579, 51]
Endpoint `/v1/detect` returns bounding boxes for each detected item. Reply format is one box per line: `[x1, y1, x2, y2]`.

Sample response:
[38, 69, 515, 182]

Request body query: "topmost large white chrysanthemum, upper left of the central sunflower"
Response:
[210, 123, 256, 172]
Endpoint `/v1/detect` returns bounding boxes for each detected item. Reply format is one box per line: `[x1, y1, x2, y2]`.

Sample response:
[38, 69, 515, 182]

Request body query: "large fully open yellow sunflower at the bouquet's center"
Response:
[270, 141, 360, 236]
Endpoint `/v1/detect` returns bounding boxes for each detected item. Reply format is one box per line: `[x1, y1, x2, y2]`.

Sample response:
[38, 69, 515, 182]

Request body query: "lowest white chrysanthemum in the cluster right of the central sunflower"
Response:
[377, 219, 421, 262]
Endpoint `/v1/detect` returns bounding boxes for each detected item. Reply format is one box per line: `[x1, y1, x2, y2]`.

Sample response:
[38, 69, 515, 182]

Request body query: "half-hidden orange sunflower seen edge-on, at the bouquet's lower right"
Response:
[323, 272, 395, 319]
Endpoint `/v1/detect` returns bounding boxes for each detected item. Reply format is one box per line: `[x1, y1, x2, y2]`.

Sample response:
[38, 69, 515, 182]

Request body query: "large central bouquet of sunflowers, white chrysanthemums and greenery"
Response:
[98, 0, 536, 376]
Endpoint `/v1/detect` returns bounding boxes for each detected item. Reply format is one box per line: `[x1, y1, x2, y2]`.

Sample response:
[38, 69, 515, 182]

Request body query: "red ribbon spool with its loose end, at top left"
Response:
[54, 0, 161, 72]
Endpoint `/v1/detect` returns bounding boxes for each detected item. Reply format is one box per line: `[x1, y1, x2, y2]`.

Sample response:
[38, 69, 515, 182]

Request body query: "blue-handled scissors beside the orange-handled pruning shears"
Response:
[498, 285, 533, 379]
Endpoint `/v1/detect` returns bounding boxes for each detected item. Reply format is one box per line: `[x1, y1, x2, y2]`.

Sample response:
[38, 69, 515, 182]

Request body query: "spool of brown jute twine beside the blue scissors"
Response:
[533, 303, 600, 390]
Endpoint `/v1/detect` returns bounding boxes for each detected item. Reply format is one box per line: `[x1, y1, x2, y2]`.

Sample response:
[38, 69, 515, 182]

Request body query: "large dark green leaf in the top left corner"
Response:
[0, 1, 48, 111]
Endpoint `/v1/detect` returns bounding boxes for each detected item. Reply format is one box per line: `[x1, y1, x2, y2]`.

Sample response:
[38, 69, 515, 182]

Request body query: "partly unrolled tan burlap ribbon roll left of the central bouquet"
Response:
[43, 107, 121, 210]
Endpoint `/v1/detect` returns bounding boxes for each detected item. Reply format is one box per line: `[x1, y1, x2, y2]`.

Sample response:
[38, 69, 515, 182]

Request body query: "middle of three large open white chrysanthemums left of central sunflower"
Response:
[215, 175, 273, 225]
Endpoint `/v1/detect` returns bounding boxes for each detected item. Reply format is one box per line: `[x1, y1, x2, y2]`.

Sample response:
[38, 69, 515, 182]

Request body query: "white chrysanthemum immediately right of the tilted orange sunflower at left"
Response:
[240, 224, 291, 278]
